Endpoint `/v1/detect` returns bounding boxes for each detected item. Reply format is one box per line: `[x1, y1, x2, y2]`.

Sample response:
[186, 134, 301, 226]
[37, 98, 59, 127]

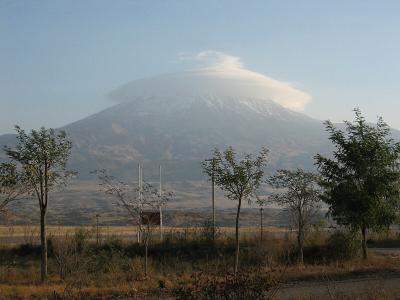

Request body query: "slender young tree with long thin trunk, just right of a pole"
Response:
[202, 147, 268, 275]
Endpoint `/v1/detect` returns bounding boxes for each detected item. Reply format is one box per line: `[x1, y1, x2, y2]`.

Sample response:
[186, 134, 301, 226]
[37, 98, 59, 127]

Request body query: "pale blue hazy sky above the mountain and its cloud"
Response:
[0, 0, 400, 133]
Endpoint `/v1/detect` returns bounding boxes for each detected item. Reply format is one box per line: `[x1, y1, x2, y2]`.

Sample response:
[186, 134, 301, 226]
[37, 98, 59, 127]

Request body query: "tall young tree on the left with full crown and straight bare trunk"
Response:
[4, 126, 71, 282]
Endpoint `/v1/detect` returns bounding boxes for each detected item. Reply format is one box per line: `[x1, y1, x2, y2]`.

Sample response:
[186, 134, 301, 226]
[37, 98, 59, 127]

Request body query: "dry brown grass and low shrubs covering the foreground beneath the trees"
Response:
[0, 226, 400, 299]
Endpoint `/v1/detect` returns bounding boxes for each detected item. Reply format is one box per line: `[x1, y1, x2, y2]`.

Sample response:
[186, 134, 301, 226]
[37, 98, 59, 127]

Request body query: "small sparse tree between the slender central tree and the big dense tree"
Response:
[268, 169, 320, 264]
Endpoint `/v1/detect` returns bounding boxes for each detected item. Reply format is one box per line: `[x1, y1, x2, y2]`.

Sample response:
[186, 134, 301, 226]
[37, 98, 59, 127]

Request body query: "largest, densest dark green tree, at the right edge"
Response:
[315, 109, 400, 259]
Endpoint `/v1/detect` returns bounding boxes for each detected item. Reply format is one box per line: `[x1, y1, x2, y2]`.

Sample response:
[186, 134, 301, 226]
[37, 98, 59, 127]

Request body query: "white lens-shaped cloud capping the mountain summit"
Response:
[110, 51, 311, 111]
